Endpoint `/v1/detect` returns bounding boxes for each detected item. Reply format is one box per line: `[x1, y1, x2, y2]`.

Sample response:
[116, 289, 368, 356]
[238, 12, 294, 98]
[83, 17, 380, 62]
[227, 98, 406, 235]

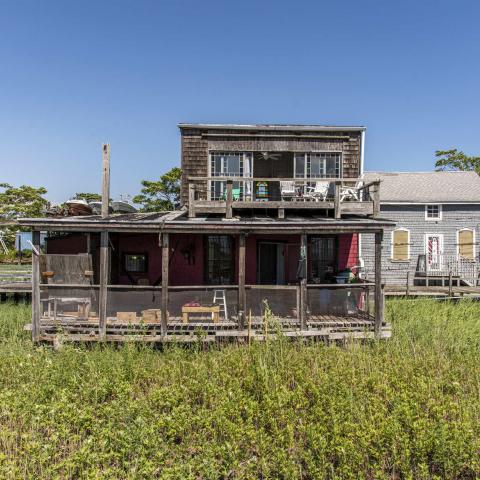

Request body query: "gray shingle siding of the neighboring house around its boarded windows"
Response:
[361, 204, 480, 284]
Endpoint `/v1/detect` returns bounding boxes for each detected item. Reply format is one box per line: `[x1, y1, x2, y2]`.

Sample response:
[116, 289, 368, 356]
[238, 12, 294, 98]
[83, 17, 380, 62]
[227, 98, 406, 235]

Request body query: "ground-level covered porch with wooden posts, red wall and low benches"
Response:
[20, 212, 390, 342]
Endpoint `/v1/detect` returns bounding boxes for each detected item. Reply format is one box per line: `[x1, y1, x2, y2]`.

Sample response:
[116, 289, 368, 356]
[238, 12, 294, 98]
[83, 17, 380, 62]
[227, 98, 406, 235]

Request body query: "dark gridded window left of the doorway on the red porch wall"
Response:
[205, 235, 234, 285]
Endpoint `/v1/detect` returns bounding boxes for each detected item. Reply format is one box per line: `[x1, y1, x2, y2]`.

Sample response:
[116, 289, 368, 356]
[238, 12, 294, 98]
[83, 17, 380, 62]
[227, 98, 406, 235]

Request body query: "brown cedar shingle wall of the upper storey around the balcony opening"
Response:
[181, 128, 361, 205]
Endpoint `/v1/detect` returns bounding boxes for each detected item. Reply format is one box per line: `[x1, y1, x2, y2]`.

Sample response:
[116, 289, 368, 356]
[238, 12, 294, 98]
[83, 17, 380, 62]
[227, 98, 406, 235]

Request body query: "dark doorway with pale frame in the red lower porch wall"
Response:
[257, 242, 285, 285]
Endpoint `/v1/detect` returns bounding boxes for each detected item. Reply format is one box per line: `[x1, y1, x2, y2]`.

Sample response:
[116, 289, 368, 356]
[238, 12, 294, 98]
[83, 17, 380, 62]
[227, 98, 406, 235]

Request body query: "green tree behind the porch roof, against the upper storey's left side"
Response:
[133, 167, 182, 212]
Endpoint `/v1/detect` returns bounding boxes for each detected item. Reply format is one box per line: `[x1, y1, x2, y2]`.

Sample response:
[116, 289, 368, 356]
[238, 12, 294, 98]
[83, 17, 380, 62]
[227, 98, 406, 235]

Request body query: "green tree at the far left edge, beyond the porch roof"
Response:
[0, 183, 48, 248]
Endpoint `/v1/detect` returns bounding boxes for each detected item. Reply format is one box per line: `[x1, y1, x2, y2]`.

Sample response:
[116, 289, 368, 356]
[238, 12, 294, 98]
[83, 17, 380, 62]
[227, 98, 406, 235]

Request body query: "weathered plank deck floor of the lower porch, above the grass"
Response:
[26, 315, 391, 344]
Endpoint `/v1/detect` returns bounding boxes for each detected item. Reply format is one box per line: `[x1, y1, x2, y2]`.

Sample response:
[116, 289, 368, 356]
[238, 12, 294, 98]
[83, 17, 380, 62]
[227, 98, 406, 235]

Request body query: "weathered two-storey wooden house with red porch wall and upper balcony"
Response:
[21, 124, 393, 342]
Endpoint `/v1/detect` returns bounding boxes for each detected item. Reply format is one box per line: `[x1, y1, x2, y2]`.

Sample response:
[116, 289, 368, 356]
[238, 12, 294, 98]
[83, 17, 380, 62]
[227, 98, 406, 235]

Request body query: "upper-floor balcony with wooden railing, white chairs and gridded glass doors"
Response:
[186, 151, 380, 218]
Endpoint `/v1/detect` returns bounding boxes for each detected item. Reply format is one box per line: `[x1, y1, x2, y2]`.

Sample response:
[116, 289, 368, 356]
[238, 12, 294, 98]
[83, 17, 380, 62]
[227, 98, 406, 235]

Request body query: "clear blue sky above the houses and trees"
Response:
[0, 0, 480, 201]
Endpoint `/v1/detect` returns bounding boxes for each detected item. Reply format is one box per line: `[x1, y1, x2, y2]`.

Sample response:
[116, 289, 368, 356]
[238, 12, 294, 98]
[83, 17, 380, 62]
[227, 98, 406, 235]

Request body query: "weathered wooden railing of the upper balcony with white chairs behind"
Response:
[188, 176, 380, 218]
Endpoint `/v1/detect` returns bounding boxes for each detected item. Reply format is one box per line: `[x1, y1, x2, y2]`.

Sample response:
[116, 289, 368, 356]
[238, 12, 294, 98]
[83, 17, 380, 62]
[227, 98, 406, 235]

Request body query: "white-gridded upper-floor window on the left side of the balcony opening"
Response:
[209, 152, 253, 200]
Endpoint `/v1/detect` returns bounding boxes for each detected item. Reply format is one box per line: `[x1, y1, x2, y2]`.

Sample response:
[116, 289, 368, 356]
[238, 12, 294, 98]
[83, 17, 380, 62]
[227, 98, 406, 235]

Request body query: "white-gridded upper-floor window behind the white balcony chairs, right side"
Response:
[295, 152, 342, 178]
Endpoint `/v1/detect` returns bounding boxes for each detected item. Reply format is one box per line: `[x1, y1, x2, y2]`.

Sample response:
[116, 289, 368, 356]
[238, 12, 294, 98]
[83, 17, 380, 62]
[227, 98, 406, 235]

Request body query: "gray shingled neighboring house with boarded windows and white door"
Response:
[359, 172, 480, 285]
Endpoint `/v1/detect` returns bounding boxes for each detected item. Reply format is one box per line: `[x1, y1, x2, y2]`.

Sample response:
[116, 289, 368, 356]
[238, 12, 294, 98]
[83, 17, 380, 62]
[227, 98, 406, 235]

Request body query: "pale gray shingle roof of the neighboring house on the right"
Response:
[365, 171, 480, 204]
